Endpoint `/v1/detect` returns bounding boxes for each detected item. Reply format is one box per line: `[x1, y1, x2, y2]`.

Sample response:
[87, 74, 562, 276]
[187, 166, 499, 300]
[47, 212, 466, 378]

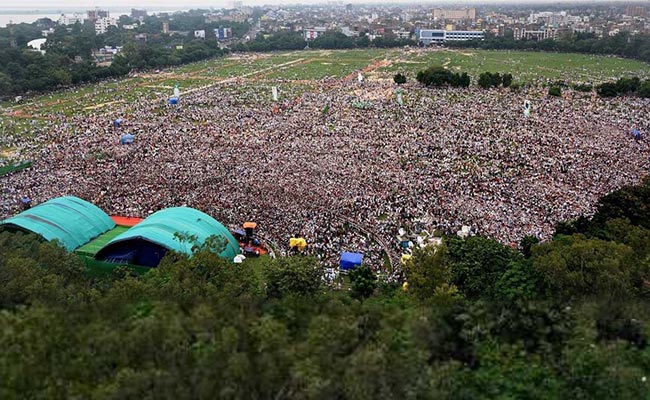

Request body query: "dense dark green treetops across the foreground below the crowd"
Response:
[0, 180, 650, 400]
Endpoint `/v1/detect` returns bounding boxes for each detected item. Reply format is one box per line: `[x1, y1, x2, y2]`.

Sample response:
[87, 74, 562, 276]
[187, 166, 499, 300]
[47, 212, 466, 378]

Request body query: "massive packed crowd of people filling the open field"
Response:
[0, 80, 650, 268]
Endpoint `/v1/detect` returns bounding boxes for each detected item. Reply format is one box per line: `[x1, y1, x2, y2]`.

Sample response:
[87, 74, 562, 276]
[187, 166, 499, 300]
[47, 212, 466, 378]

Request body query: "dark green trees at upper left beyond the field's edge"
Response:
[0, 12, 250, 98]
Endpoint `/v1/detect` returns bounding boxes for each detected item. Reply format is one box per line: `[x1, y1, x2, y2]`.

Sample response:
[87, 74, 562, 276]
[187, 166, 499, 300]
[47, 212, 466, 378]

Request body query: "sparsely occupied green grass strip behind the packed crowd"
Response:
[0, 49, 650, 150]
